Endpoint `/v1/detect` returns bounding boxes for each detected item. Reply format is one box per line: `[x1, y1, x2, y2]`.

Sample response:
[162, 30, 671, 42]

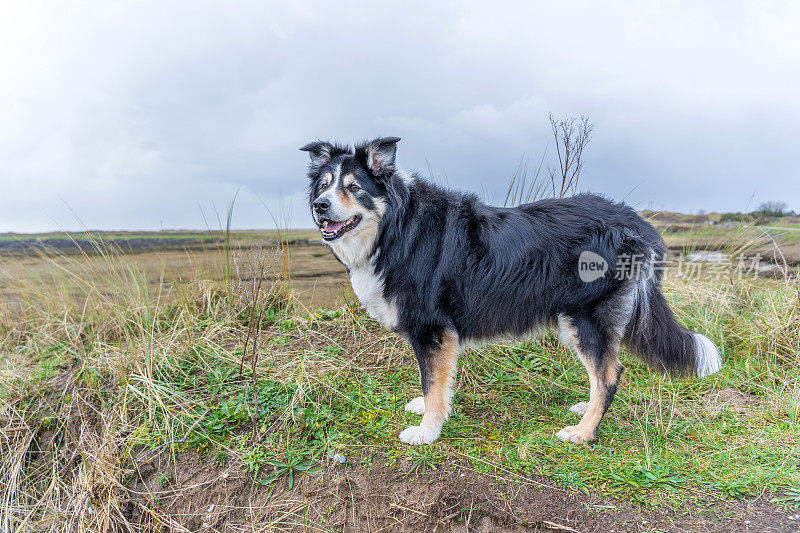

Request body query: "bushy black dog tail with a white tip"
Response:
[623, 275, 722, 377]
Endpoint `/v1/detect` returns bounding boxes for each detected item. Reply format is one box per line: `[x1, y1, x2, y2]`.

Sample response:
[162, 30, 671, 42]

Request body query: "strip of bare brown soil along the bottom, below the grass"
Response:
[123, 453, 797, 533]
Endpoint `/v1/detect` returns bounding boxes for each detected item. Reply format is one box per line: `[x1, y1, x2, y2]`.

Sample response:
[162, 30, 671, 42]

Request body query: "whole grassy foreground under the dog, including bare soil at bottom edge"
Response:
[0, 231, 800, 532]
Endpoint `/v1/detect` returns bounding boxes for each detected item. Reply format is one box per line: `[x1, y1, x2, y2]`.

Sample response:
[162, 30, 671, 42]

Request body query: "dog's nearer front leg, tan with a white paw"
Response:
[400, 330, 459, 444]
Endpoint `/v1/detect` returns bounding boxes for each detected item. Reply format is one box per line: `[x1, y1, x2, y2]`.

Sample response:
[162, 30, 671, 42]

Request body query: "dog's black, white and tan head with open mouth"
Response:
[301, 137, 400, 264]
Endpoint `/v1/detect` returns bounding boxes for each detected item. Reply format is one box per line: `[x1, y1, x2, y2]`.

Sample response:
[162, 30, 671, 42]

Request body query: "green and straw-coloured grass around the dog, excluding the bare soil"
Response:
[0, 243, 800, 531]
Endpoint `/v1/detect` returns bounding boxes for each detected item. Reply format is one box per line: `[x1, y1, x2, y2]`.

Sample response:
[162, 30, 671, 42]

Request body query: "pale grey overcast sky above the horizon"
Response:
[0, 0, 800, 231]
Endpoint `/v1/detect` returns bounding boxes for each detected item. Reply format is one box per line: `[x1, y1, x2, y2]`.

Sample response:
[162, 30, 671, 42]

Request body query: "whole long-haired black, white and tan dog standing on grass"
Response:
[301, 137, 722, 444]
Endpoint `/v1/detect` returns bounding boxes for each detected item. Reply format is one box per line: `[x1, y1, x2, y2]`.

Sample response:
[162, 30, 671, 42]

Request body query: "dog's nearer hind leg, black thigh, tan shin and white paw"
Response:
[556, 317, 624, 444]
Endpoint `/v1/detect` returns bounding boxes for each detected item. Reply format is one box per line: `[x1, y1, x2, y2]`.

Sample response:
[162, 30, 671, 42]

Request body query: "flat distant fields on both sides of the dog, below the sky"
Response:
[0, 219, 800, 316]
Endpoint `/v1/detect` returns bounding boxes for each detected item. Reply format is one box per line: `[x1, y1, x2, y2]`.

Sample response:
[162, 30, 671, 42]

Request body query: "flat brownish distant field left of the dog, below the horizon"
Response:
[0, 229, 348, 305]
